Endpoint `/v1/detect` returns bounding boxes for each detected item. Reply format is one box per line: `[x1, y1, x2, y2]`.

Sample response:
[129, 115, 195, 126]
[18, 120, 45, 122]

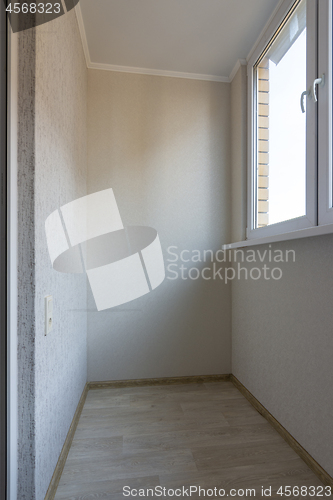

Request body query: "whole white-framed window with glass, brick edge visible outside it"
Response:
[247, 0, 333, 239]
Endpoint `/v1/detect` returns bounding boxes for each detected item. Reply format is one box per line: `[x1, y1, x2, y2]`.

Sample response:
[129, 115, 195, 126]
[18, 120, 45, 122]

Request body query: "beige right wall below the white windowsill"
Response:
[232, 65, 333, 475]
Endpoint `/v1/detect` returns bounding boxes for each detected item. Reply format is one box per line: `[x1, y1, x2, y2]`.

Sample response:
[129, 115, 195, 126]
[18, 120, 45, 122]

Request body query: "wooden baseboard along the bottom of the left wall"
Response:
[44, 384, 89, 500]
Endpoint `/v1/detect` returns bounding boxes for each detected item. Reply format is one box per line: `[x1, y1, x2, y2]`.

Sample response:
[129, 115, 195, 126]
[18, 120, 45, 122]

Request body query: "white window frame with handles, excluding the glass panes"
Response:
[246, 0, 333, 240]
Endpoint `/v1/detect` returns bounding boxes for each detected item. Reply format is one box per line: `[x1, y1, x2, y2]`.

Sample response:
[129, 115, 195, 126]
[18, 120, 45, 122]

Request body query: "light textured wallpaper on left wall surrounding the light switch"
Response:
[35, 10, 87, 500]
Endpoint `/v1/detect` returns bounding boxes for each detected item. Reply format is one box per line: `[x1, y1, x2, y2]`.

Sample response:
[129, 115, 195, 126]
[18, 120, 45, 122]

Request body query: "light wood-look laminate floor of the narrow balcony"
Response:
[55, 382, 327, 500]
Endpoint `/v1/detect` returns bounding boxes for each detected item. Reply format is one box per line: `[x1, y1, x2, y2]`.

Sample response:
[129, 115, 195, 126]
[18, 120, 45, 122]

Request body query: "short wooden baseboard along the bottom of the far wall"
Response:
[88, 374, 230, 389]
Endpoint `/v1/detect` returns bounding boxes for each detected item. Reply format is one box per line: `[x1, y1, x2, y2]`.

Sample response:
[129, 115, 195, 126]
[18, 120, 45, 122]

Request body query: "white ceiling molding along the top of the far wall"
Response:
[87, 62, 230, 83]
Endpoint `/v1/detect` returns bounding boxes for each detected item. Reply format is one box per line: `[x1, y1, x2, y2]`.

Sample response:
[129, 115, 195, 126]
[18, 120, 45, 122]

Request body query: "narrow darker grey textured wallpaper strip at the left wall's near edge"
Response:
[17, 25, 35, 500]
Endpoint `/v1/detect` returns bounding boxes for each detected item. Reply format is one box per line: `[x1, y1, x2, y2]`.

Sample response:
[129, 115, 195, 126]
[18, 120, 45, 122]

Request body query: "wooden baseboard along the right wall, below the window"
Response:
[230, 375, 333, 487]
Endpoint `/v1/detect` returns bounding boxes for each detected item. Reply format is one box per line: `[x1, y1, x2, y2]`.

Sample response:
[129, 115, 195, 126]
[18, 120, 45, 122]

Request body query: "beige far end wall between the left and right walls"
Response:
[88, 70, 231, 380]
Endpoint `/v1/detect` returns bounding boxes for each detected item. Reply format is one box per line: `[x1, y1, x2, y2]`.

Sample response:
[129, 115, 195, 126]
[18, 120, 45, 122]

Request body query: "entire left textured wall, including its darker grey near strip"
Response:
[19, 11, 87, 500]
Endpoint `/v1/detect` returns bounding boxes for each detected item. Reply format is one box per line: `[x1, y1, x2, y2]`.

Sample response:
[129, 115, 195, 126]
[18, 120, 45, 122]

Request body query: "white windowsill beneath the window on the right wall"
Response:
[222, 224, 333, 250]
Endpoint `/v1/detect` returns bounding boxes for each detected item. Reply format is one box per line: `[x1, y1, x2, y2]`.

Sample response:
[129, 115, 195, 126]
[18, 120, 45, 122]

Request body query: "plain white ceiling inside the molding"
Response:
[78, 0, 279, 80]
